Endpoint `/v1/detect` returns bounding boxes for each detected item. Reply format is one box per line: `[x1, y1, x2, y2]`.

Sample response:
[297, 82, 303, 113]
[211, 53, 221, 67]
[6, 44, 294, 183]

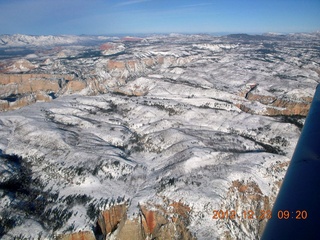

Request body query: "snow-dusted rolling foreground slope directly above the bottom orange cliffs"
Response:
[1, 95, 299, 239]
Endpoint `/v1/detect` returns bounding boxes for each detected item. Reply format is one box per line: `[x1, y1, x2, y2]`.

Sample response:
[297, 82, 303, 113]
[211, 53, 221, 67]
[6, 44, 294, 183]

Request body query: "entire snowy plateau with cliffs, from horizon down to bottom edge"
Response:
[0, 33, 320, 239]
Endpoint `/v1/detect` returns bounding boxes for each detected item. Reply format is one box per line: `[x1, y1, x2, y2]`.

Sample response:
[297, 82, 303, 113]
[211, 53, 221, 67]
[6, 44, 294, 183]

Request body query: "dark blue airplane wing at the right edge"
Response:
[261, 84, 320, 240]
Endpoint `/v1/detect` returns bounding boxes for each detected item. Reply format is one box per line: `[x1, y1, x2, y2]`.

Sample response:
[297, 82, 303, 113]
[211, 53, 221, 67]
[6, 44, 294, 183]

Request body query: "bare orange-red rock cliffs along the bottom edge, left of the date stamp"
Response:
[59, 201, 195, 240]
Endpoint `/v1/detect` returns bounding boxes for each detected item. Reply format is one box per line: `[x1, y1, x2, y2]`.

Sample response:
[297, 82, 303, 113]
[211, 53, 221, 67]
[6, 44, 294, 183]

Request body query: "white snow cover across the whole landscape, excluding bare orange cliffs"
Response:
[0, 32, 319, 239]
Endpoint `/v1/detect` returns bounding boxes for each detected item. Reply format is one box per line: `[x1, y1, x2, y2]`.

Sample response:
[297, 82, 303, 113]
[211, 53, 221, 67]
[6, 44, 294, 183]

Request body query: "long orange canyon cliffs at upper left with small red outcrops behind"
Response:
[0, 53, 196, 111]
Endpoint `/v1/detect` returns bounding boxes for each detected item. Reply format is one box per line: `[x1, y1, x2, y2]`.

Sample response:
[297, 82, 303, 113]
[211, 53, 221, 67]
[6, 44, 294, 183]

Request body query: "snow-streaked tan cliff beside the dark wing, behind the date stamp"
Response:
[216, 158, 289, 239]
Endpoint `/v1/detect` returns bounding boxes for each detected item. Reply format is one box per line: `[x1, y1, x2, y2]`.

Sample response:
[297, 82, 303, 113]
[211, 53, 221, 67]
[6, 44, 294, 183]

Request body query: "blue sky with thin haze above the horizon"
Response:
[0, 0, 320, 35]
